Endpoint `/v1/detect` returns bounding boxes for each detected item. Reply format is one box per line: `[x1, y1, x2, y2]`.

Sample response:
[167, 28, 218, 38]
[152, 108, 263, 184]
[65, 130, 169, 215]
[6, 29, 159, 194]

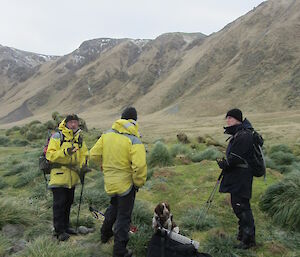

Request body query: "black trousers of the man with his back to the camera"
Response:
[101, 187, 136, 257]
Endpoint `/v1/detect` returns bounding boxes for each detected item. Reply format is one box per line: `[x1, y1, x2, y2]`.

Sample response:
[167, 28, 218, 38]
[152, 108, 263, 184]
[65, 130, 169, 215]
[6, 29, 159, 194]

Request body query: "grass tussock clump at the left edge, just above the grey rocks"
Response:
[0, 198, 33, 229]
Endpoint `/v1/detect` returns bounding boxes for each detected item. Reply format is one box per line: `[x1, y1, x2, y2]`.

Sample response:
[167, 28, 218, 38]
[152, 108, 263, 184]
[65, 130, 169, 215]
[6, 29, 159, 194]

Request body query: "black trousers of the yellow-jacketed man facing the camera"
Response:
[52, 187, 75, 234]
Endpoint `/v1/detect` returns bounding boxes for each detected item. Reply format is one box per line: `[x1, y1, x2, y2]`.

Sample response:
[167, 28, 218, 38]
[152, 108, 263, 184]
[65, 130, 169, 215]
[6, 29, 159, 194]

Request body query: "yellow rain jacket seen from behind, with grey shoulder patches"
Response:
[90, 119, 147, 196]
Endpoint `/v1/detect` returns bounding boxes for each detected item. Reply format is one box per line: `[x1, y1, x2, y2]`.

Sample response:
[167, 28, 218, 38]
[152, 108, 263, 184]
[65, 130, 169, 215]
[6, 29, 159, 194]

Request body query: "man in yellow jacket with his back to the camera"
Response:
[90, 107, 147, 257]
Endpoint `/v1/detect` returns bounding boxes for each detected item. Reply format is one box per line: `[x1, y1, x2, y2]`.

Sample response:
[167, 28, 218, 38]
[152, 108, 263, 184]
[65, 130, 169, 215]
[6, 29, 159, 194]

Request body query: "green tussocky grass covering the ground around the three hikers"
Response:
[0, 122, 300, 257]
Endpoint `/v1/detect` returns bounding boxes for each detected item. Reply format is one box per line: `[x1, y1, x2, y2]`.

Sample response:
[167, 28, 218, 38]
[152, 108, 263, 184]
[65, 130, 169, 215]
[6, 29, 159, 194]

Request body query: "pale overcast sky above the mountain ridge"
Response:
[0, 0, 263, 55]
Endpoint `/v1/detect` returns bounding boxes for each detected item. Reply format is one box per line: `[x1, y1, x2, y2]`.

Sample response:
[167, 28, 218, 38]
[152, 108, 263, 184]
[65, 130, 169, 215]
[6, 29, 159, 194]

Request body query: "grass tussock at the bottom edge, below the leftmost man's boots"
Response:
[19, 236, 88, 257]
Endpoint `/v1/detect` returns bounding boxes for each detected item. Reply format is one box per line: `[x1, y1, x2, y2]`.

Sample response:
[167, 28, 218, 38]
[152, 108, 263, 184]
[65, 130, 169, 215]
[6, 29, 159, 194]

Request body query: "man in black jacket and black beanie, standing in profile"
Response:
[217, 109, 256, 249]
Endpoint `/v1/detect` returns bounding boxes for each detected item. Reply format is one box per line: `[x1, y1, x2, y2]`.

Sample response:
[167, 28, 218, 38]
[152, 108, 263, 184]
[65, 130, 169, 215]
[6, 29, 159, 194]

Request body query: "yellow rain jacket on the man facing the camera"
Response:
[46, 120, 88, 188]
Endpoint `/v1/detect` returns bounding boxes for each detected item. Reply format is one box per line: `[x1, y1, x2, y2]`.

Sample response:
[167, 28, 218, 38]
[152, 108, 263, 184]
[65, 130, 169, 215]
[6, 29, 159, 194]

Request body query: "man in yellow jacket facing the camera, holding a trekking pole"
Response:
[46, 114, 88, 241]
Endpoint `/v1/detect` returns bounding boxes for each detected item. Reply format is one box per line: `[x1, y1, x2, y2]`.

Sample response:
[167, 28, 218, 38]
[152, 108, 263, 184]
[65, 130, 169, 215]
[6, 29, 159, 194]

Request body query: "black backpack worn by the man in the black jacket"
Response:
[250, 130, 266, 177]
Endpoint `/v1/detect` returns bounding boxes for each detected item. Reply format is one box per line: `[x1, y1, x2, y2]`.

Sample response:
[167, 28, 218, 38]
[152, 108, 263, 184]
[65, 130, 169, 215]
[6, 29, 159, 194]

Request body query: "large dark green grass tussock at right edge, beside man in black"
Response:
[260, 172, 300, 231]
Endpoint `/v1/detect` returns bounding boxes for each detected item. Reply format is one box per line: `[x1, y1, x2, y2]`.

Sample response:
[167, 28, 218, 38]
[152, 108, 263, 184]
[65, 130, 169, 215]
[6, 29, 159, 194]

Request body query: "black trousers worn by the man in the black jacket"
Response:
[231, 194, 255, 244]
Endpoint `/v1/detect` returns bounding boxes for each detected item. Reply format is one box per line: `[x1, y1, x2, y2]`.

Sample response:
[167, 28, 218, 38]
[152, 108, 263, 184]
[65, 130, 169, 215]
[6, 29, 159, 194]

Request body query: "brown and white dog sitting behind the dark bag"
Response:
[152, 202, 179, 233]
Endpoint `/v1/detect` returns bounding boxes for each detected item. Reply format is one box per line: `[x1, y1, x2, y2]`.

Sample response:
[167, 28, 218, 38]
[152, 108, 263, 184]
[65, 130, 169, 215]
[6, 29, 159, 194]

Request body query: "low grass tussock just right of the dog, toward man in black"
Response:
[181, 209, 218, 231]
